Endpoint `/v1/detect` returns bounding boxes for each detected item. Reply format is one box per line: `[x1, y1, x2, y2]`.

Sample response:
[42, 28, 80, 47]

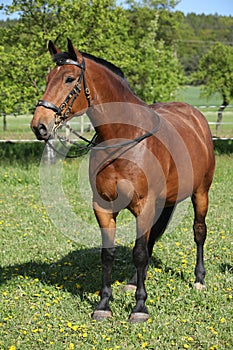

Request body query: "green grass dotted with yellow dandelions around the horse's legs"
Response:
[0, 155, 233, 350]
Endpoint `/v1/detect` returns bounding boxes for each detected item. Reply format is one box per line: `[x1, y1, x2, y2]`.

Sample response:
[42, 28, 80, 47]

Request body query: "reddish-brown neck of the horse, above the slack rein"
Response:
[87, 63, 148, 141]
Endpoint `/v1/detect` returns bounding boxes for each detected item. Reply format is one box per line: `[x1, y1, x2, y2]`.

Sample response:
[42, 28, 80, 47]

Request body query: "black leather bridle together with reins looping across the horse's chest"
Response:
[36, 57, 161, 158]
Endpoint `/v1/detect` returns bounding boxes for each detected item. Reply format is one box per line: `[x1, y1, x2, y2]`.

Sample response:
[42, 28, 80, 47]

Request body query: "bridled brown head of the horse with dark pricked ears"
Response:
[31, 39, 90, 141]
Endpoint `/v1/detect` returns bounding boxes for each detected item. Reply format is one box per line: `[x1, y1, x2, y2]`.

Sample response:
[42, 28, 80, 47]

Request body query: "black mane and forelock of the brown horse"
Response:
[53, 51, 125, 79]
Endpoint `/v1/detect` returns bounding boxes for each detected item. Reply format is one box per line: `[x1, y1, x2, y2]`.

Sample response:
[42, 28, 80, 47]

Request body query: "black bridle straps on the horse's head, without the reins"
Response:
[36, 57, 90, 130]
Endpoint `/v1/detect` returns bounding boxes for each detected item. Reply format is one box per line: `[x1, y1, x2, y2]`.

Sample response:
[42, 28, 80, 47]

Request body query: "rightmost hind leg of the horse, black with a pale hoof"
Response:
[192, 190, 208, 290]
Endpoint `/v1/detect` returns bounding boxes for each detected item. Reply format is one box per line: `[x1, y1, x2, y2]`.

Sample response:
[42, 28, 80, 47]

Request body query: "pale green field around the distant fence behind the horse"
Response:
[0, 86, 233, 140]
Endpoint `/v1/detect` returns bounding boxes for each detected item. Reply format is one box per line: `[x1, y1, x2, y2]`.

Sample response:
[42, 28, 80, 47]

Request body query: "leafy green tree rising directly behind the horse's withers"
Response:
[125, 1, 183, 103]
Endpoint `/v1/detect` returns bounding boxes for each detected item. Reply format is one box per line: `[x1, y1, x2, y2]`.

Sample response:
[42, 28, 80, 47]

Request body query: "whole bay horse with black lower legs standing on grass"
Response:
[31, 39, 215, 322]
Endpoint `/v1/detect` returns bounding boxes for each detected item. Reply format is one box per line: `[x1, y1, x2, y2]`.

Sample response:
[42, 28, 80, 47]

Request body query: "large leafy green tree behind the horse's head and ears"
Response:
[0, 0, 133, 113]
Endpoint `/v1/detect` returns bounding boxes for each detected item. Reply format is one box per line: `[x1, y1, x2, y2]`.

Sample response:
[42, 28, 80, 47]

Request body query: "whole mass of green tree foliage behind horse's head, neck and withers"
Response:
[0, 0, 186, 113]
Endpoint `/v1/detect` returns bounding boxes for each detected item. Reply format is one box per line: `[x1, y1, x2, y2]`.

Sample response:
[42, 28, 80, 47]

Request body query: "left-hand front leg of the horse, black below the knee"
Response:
[92, 203, 117, 321]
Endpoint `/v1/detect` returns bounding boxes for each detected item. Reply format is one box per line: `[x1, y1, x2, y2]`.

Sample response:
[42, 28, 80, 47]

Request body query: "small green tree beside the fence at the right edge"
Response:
[193, 43, 233, 130]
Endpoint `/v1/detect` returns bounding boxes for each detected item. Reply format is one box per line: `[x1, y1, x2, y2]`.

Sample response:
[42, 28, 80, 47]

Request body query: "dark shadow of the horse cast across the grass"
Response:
[0, 246, 164, 299]
